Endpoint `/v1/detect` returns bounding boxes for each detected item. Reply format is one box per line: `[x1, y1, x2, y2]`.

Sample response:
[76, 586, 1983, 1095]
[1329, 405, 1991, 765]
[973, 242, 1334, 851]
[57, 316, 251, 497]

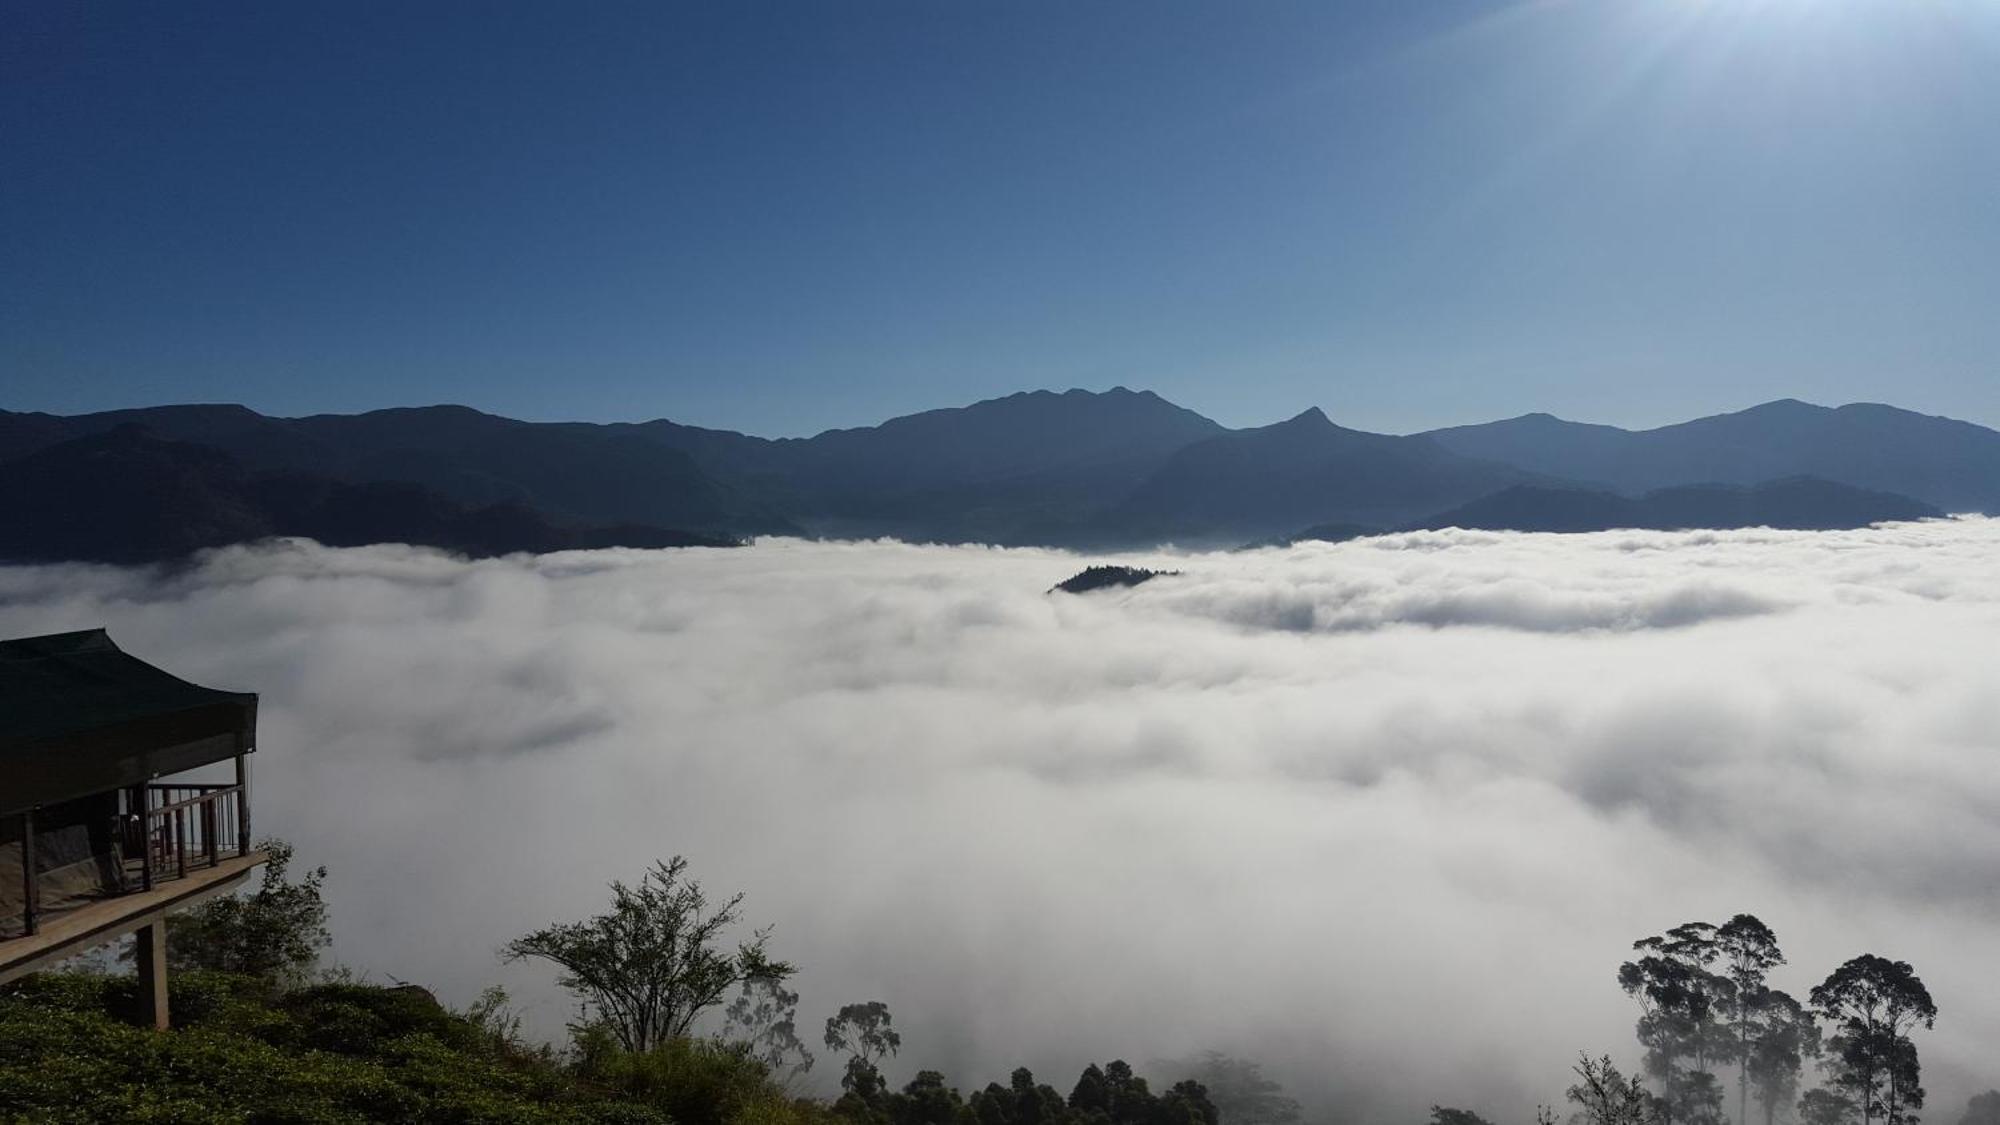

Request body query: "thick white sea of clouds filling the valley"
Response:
[0, 518, 2000, 1125]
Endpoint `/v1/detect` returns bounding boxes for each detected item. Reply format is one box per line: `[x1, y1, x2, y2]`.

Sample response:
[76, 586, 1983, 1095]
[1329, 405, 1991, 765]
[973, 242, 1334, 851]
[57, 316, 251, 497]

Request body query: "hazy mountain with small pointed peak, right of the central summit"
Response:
[1106, 408, 1534, 544]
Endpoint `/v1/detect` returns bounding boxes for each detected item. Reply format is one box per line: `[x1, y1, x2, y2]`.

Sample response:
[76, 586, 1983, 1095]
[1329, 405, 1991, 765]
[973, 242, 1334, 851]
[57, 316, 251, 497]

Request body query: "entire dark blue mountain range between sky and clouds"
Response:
[0, 388, 1976, 560]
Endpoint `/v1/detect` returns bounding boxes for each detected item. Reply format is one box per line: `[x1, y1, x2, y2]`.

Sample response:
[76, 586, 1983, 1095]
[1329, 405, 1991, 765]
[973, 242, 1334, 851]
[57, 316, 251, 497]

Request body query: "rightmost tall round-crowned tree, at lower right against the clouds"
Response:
[1812, 953, 1938, 1125]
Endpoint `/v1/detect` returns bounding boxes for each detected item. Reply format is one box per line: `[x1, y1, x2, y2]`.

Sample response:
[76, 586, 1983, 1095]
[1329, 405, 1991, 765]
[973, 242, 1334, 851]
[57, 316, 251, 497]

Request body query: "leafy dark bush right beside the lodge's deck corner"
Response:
[166, 839, 330, 985]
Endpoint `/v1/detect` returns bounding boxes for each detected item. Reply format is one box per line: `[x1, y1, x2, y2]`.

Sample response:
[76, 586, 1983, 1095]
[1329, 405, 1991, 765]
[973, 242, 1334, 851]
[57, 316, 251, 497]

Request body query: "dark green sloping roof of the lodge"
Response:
[0, 629, 256, 815]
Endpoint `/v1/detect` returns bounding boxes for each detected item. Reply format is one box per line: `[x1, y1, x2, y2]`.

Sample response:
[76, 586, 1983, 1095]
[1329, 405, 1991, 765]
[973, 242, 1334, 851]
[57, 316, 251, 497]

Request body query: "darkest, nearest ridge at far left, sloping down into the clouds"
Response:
[0, 424, 728, 563]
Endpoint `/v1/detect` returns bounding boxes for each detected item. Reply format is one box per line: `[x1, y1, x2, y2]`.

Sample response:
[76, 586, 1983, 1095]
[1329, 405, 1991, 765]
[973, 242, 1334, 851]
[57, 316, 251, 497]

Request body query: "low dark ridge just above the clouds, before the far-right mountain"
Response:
[1412, 476, 1944, 530]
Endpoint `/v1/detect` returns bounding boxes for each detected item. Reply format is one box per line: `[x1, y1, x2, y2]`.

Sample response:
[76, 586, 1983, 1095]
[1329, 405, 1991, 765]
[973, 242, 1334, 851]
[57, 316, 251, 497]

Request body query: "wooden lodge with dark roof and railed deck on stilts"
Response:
[0, 629, 264, 1027]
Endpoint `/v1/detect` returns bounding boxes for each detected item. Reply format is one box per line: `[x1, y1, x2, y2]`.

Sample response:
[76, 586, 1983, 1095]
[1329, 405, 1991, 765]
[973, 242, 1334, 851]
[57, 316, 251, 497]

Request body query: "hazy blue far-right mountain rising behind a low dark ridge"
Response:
[1428, 398, 2000, 512]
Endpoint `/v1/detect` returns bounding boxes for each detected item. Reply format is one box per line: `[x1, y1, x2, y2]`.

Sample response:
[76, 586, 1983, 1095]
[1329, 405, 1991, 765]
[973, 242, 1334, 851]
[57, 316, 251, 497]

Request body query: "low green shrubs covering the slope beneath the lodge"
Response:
[0, 973, 668, 1125]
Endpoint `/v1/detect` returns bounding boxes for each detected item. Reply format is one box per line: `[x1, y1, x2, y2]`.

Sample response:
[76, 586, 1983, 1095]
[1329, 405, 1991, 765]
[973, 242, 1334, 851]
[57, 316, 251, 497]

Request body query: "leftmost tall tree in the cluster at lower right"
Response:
[1618, 923, 1734, 1125]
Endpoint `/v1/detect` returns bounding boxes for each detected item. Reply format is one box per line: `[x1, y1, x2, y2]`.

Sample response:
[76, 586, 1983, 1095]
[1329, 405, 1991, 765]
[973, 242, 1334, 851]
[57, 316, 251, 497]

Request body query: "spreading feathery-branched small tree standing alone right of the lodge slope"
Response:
[500, 855, 794, 1051]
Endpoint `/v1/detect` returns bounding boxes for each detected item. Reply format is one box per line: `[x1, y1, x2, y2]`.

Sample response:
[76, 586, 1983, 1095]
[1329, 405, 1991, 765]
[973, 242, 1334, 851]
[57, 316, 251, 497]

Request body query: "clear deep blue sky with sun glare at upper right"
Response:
[0, 0, 2000, 434]
